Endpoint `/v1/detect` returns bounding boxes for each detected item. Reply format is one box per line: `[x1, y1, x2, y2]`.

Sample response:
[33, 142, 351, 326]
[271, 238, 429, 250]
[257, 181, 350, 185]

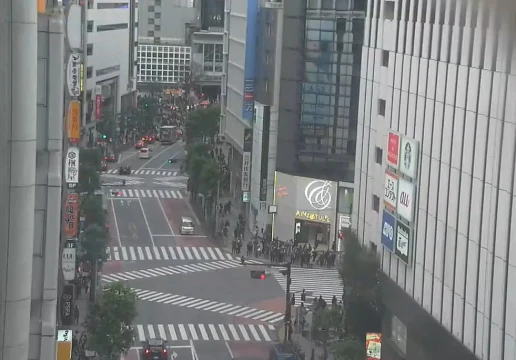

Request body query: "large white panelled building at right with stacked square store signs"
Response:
[352, 0, 516, 360]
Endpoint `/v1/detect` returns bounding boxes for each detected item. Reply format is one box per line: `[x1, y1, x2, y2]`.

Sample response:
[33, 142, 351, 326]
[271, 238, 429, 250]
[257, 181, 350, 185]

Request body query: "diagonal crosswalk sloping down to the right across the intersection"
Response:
[132, 289, 284, 324]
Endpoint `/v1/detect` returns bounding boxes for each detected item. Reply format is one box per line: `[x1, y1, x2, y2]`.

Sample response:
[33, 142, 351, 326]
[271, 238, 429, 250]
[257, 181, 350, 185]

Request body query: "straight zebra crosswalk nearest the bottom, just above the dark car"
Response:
[135, 324, 277, 342]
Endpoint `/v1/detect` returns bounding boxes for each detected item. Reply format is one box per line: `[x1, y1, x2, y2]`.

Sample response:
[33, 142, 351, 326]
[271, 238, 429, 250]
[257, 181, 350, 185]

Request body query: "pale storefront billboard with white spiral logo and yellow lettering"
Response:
[274, 171, 338, 241]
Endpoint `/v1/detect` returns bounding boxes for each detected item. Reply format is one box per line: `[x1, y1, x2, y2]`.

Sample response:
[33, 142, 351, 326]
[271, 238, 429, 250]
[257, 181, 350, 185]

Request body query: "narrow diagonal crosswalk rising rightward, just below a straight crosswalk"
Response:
[101, 260, 264, 283]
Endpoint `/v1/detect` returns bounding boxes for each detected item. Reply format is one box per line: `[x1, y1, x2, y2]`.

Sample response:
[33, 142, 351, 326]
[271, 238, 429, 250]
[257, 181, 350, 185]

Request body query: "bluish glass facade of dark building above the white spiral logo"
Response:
[298, 0, 364, 181]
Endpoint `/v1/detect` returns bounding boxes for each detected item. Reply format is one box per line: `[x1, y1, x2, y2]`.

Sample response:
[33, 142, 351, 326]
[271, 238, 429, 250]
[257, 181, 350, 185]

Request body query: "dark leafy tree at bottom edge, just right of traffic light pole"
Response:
[312, 307, 366, 360]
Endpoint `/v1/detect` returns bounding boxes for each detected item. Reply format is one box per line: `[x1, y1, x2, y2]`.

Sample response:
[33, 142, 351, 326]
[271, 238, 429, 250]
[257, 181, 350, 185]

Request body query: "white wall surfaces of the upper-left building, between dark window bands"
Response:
[85, 0, 134, 121]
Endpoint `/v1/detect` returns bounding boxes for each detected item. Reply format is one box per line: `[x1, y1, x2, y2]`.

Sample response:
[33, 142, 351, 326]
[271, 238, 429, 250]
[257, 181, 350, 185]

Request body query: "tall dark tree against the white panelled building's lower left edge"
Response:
[339, 229, 384, 339]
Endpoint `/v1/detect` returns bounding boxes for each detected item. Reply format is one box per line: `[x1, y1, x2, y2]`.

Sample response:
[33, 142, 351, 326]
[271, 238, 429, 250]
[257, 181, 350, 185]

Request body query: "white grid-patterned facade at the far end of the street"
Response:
[138, 44, 191, 84]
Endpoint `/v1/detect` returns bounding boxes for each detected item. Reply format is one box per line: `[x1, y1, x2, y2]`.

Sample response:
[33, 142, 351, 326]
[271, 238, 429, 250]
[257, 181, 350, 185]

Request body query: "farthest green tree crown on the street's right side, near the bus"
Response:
[185, 106, 220, 144]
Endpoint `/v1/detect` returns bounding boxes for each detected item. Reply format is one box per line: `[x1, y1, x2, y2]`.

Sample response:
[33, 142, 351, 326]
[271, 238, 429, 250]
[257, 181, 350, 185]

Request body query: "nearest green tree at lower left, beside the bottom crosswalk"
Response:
[87, 282, 137, 360]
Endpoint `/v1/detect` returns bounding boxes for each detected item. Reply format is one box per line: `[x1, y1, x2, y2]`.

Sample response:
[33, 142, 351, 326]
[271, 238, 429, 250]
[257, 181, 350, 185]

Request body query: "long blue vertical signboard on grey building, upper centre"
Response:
[242, 0, 259, 121]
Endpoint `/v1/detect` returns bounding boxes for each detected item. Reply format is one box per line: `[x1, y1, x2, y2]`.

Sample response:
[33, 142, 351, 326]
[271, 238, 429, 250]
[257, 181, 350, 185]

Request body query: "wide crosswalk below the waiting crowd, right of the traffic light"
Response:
[273, 268, 343, 304]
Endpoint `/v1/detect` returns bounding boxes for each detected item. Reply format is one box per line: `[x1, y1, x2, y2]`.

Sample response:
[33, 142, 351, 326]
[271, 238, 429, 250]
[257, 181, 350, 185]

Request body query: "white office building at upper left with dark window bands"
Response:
[83, 0, 138, 142]
